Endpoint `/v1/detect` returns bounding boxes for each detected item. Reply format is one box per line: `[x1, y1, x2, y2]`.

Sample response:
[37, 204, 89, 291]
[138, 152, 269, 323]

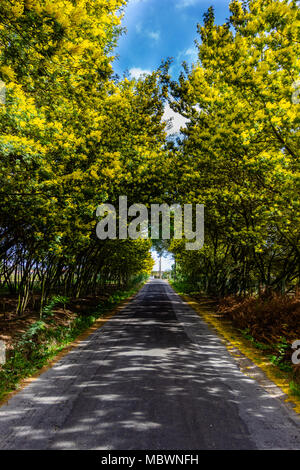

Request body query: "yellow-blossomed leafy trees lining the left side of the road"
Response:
[0, 0, 169, 314]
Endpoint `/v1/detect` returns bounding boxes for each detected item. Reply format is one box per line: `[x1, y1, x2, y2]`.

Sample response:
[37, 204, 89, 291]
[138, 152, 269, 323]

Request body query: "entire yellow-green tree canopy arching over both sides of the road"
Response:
[0, 0, 300, 320]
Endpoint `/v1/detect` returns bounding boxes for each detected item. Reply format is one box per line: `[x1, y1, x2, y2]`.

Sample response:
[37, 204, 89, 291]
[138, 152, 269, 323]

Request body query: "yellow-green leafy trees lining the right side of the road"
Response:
[171, 0, 300, 295]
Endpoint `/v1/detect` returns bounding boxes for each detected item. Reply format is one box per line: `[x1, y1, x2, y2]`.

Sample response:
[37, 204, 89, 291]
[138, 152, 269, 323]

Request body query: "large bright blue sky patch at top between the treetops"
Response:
[114, 0, 229, 78]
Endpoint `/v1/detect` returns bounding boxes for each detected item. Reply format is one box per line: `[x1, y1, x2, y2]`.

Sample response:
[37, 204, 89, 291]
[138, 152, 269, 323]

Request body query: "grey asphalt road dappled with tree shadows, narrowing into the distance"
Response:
[0, 281, 300, 450]
